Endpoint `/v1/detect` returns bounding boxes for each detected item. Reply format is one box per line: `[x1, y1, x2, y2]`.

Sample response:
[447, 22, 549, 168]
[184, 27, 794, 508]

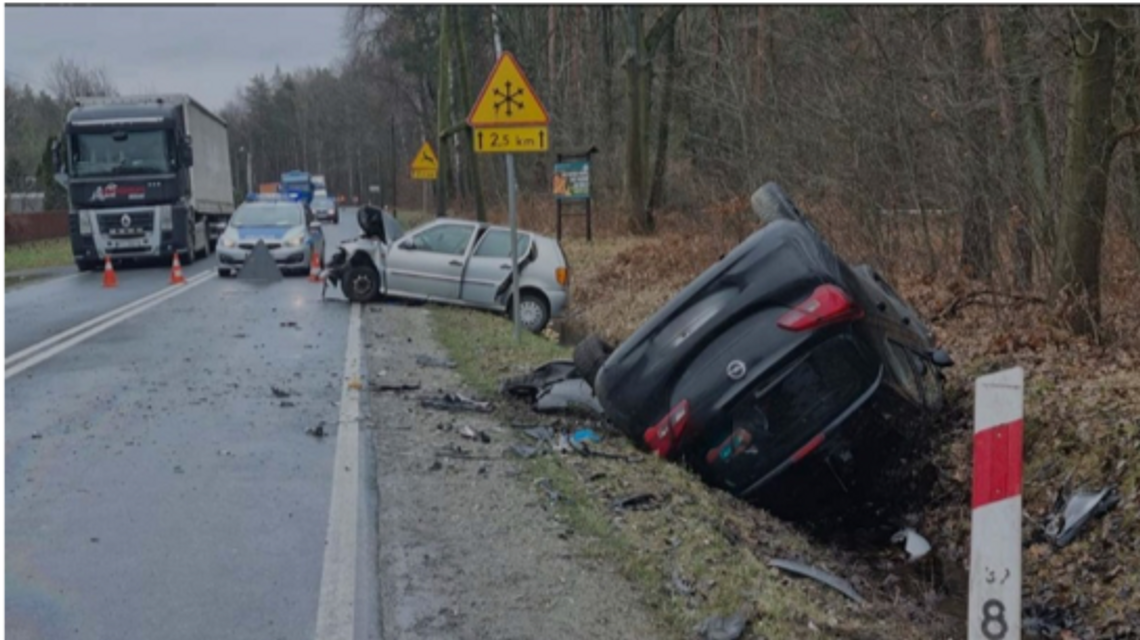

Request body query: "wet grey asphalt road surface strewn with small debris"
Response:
[0, 218, 376, 640]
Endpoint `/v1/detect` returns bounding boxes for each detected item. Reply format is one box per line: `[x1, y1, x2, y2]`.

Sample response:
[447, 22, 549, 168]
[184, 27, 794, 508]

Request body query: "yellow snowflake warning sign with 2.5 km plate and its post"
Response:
[467, 13, 551, 342]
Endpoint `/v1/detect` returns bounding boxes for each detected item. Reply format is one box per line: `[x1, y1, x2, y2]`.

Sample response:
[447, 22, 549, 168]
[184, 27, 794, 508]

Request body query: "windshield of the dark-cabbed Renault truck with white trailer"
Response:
[72, 130, 173, 178]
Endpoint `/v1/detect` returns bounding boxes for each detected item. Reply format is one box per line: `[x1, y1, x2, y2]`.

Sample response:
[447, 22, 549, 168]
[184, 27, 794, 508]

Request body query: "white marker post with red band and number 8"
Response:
[968, 367, 1025, 640]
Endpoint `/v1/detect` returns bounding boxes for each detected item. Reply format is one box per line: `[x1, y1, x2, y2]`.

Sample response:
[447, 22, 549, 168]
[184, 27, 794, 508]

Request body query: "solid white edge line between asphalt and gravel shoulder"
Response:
[316, 302, 360, 640]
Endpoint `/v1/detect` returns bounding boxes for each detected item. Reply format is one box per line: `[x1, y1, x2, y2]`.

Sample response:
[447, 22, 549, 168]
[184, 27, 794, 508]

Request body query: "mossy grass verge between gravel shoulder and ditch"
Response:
[432, 308, 961, 639]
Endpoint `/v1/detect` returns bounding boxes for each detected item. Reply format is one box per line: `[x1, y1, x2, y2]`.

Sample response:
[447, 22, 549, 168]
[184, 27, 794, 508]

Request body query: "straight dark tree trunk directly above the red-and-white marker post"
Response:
[961, 7, 994, 280]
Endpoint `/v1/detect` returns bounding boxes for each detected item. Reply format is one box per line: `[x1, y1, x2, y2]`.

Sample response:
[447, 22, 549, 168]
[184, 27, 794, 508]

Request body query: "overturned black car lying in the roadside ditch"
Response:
[575, 183, 952, 508]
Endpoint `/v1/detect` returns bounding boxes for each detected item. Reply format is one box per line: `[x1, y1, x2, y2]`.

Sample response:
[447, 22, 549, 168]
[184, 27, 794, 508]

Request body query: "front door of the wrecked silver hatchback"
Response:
[386, 221, 475, 300]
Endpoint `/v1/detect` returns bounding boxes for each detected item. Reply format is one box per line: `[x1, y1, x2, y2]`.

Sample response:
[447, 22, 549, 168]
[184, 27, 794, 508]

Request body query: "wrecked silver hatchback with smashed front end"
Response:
[327, 205, 570, 333]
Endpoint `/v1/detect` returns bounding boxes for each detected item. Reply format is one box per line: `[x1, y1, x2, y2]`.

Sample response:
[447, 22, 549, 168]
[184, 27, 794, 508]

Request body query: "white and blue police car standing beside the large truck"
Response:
[218, 196, 325, 276]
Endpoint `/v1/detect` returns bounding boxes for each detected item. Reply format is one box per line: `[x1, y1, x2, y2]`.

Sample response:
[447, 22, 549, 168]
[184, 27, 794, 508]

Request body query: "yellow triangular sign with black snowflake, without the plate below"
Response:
[467, 51, 551, 129]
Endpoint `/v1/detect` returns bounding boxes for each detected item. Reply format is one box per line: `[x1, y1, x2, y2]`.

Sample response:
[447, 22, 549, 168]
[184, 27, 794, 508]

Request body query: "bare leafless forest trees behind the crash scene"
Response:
[0, 5, 1140, 334]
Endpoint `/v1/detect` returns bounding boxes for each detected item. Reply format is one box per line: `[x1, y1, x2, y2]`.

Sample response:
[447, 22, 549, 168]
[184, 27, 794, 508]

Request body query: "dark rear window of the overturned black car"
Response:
[700, 335, 874, 486]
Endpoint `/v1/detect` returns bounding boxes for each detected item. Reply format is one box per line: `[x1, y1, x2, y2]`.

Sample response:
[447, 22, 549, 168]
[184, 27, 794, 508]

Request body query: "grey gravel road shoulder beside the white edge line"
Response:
[364, 306, 666, 640]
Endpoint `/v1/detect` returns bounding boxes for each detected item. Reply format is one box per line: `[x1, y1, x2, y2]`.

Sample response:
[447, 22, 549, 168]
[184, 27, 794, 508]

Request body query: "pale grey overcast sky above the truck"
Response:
[0, 6, 345, 110]
